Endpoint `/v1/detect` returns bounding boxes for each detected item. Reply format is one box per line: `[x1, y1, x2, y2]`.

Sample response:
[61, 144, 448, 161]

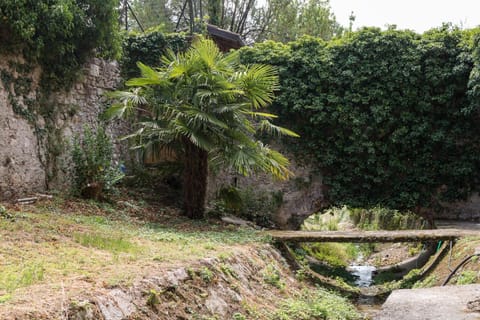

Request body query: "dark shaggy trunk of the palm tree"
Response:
[183, 139, 208, 219]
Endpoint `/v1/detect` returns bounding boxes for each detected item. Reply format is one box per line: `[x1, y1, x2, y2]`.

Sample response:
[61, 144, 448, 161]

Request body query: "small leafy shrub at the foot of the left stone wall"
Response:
[72, 126, 124, 200]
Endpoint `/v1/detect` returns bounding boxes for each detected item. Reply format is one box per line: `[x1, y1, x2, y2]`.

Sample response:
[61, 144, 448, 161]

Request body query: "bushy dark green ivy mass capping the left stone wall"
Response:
[0, 0, 120, 89]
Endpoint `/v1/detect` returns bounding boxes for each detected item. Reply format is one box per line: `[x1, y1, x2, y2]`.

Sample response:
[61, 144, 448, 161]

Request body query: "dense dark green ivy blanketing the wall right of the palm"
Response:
[241, 26, 480, 209]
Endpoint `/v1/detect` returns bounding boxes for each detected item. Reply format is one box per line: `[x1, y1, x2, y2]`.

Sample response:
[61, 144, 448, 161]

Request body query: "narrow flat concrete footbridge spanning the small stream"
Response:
[267, 229, 480, 243]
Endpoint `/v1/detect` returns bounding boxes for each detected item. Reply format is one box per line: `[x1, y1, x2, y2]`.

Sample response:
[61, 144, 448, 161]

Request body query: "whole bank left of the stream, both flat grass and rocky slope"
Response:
[0, 198, 362, 320]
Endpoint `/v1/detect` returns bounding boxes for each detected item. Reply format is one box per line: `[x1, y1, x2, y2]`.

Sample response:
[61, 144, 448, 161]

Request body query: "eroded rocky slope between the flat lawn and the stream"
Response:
[0, 245, 361, 320]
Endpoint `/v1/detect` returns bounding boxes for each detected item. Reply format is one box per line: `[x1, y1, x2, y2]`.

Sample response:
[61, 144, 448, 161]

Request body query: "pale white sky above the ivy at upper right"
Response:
[330, 0, 480, 33]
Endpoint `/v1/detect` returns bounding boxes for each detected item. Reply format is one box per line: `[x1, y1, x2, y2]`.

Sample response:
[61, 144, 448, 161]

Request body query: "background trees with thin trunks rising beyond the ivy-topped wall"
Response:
[127, 0, 343, 43]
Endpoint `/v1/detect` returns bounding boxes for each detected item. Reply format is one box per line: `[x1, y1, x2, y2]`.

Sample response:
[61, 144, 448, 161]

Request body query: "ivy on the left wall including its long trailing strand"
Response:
[0, 0, 120, 186]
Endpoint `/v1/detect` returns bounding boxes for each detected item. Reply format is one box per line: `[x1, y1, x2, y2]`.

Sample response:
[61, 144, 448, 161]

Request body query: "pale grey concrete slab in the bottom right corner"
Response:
[373, 284, 480, 320]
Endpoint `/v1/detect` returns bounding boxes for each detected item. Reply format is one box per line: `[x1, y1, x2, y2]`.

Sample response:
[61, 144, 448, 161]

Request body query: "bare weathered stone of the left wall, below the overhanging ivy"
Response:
[0, 55, 120, 199]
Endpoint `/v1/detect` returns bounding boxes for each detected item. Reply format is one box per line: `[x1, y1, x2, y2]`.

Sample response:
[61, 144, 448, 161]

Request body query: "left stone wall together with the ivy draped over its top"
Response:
[0, 0, 121, 198]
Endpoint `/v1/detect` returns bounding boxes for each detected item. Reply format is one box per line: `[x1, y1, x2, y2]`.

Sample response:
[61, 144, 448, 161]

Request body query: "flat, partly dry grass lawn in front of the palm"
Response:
[0, 199, 269, 303]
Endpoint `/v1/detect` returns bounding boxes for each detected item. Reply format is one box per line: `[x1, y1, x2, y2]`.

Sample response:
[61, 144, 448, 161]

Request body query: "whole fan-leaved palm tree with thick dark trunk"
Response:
[107, 39, 297, 219]
